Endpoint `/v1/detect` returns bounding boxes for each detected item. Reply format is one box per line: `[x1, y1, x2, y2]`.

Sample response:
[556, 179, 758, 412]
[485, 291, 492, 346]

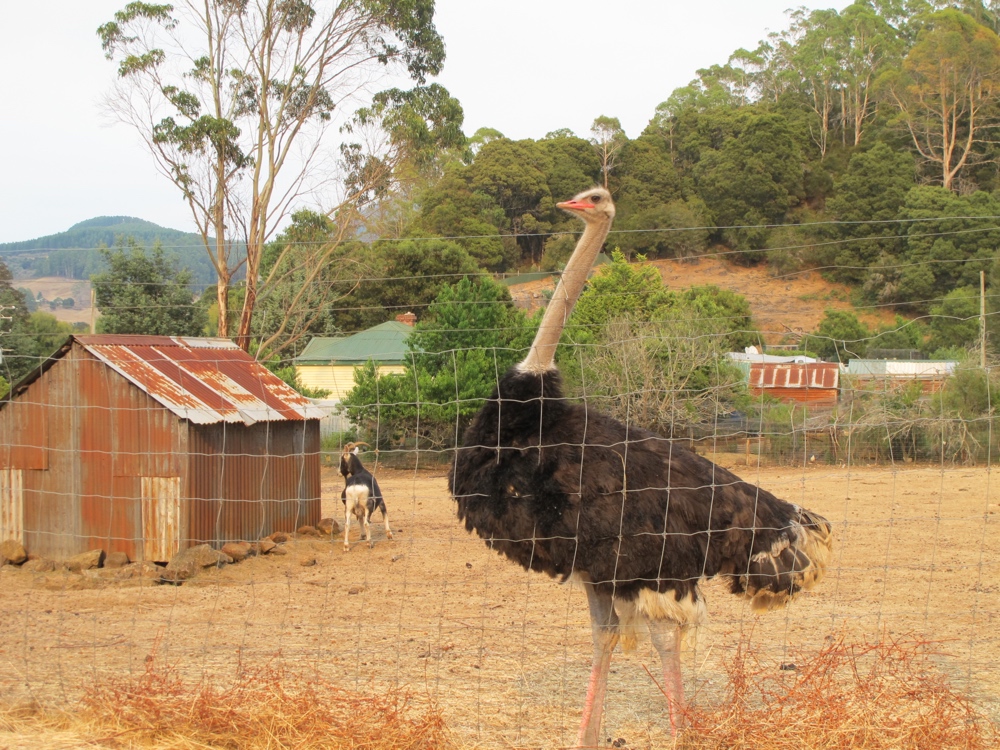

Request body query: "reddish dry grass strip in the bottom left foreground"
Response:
[0, 657, 455, 750]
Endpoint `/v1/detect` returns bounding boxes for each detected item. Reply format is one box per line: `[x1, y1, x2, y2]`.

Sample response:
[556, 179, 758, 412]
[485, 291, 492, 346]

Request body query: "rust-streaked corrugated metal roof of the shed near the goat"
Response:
[72, 335, 323, 425]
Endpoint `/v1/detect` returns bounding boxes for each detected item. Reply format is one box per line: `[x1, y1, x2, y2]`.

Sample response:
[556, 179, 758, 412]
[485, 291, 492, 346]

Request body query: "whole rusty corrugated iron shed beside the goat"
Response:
[0, 336, 321, 561]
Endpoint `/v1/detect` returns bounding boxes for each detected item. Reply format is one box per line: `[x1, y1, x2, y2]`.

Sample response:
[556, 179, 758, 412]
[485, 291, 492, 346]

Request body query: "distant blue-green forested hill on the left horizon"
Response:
[0, 216, 215, 284]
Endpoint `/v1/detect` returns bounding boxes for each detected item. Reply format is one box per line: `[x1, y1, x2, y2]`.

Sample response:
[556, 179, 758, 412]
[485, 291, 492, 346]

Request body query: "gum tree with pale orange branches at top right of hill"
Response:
[878, 9, 1000, 190]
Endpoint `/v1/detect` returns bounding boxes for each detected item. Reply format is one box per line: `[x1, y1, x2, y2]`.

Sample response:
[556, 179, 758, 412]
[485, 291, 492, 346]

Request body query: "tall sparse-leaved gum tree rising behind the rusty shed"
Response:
[98, 0, 450, 349]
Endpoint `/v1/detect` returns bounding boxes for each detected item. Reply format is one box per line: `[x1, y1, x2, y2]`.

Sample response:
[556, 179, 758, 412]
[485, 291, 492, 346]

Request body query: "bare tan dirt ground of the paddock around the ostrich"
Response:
[0, 462, 1000, 749]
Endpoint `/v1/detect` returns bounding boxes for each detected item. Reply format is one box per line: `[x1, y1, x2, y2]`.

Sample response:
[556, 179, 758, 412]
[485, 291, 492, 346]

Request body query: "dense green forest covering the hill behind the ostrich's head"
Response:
[316, 0, 1000, 344]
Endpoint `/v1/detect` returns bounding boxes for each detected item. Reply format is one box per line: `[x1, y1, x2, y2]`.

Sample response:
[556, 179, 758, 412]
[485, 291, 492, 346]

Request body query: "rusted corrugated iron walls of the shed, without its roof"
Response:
[0, 343, 320, 560]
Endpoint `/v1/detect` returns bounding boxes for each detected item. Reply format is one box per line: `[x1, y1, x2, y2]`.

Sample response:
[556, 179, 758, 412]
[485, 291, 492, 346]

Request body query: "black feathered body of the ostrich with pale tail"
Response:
[449, 368, 830, 608]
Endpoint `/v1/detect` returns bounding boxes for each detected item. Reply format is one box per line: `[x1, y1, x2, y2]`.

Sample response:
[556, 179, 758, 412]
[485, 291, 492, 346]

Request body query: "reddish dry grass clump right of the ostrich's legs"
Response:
[678, 634, 1000, 750]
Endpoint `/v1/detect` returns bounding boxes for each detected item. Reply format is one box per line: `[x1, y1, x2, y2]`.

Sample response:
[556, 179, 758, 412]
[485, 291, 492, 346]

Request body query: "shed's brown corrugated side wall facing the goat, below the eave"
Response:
[182, 419, 320, 544]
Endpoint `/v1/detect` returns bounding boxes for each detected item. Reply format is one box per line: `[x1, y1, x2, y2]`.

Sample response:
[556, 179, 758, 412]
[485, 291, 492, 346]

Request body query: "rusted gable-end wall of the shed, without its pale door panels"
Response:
[0, 345, 186, 560]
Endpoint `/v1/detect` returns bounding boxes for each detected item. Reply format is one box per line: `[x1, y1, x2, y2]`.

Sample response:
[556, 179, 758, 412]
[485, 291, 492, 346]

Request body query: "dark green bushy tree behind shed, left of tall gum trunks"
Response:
[91, 239, 208, 336]
